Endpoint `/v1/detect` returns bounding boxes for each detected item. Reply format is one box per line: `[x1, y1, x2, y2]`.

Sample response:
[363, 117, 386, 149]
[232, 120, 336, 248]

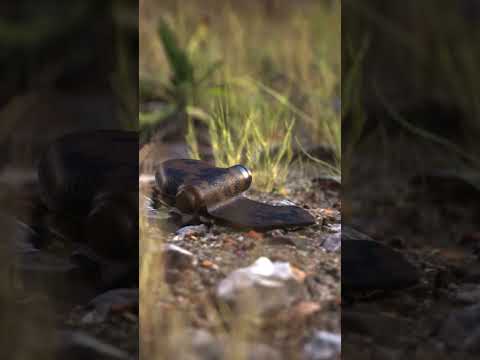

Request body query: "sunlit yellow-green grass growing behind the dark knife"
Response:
[140, 1, 341, 191]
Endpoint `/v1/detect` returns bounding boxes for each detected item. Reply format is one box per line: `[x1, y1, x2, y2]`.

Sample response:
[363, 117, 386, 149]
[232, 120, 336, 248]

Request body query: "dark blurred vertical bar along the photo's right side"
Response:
[342, 0, 480, 360]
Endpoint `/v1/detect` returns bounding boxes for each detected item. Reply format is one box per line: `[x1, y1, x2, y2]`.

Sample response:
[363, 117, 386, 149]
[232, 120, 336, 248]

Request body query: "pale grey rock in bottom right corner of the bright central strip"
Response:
[303, 331, 342, 360]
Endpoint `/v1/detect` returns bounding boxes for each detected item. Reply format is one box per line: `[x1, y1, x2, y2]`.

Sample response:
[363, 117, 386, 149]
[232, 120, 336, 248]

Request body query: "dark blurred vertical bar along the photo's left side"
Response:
[0, 0, 138, 360]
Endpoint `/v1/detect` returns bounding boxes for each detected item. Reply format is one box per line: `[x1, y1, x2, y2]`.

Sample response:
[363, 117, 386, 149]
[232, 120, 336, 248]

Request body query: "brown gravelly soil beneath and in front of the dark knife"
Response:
[140, 148, 341, 359]
